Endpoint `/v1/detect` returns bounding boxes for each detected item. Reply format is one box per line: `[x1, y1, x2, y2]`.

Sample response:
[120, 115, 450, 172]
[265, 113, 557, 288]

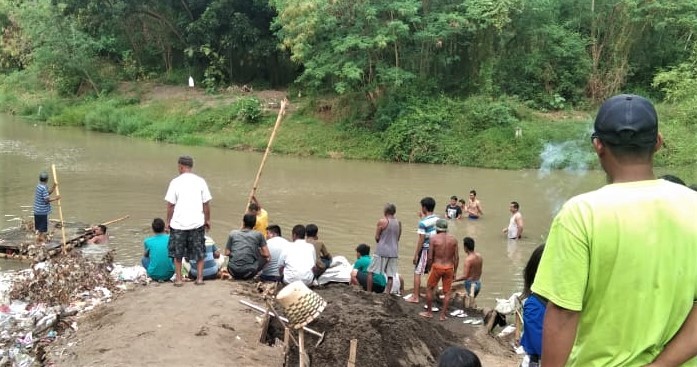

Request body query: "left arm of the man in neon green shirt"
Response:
[540, 301, 581, 367]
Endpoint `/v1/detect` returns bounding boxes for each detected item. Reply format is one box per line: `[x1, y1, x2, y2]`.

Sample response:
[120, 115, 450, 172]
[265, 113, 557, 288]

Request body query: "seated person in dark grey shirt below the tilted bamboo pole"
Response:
[225, 213, 271, 280]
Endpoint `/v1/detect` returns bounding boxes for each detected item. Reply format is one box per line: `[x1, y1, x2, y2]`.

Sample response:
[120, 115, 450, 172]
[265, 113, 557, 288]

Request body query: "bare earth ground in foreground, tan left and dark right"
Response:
[50, 281, 518, 367]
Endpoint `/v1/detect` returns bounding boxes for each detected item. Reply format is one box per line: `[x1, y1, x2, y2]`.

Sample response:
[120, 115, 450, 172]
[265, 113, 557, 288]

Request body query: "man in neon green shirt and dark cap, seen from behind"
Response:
[532, 95, 697, 367]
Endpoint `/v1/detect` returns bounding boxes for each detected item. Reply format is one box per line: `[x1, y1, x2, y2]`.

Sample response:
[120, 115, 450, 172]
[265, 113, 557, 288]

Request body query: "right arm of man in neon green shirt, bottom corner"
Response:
[646, 303, 697, 367]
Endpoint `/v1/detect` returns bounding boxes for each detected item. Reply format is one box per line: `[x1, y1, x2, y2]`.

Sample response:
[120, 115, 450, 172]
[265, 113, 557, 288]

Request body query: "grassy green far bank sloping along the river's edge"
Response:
[0, 83, 697, 182]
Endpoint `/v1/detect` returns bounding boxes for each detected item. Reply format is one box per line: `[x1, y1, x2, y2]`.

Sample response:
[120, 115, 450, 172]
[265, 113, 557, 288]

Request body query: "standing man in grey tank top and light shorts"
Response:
[366, 204, 402, 294]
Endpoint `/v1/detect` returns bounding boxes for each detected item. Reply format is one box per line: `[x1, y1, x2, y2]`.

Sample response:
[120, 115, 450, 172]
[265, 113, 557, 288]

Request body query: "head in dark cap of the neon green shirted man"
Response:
[591, 94, 663, 182]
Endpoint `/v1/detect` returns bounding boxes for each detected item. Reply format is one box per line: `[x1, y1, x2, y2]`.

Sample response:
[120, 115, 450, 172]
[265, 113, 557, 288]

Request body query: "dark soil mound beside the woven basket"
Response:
[271, 285, 510, 367]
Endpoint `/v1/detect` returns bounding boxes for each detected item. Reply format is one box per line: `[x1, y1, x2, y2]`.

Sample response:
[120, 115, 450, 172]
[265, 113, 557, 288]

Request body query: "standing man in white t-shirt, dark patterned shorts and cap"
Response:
[165, 156, 212, 287]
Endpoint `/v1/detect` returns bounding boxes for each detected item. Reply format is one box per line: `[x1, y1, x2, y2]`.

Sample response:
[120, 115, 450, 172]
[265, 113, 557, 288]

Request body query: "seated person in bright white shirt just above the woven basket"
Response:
[278, 224, 317, 286]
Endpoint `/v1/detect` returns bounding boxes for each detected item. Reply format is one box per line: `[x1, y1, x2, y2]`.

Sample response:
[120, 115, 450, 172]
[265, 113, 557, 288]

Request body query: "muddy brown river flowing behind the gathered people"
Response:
[0, 115, 605, 305]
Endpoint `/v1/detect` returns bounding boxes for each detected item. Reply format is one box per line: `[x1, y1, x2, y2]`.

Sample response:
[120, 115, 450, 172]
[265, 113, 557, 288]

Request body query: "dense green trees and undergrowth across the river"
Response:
[0, 0, 697, 180]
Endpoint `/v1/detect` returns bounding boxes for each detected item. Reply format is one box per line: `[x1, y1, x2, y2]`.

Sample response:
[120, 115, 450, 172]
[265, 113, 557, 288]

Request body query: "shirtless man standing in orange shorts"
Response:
[419, 219, 460, 321]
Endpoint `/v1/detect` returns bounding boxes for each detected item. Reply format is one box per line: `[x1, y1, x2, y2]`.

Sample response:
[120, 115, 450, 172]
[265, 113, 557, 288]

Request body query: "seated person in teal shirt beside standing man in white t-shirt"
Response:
[141, 218, 174, 282]
